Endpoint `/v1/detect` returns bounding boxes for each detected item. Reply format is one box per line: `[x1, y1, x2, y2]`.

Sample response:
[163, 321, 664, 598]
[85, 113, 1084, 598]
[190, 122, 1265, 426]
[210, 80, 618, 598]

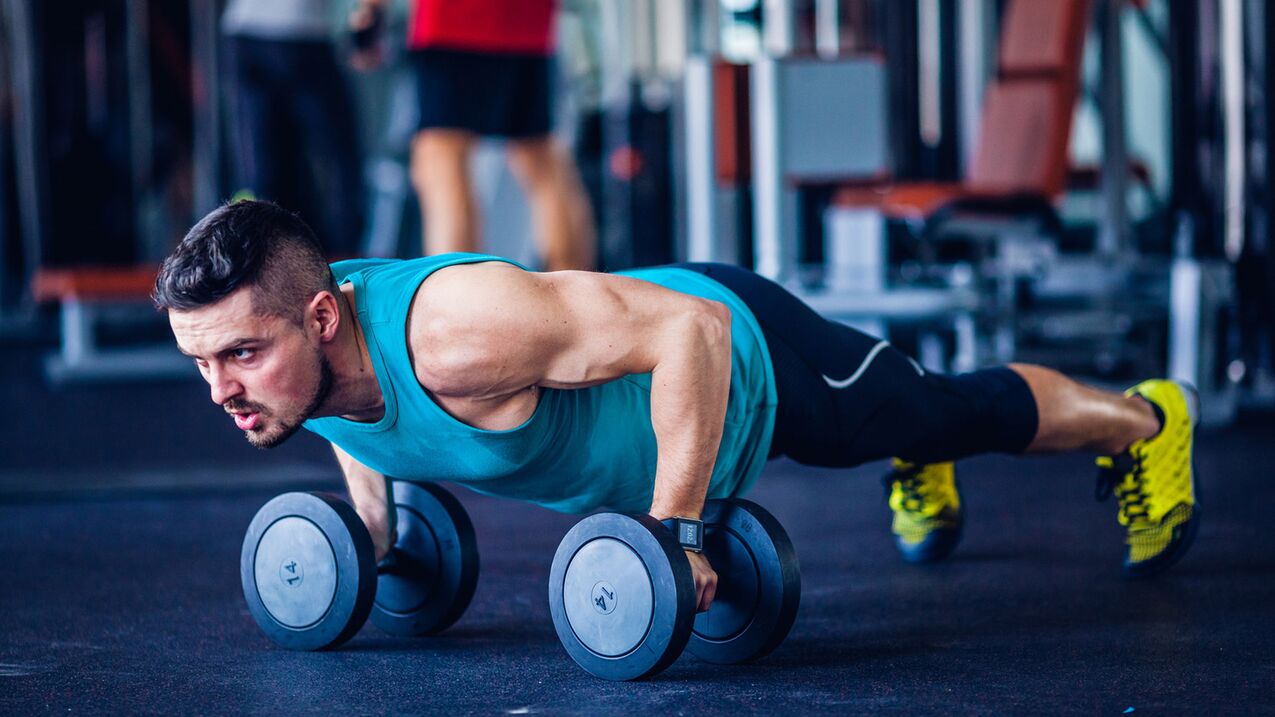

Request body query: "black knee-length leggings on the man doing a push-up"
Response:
[677, 263, 1038, 467]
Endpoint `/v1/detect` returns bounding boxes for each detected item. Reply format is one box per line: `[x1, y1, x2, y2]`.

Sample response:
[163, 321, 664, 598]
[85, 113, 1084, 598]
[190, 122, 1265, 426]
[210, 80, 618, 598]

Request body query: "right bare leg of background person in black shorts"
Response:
[507, 135, 595, 272]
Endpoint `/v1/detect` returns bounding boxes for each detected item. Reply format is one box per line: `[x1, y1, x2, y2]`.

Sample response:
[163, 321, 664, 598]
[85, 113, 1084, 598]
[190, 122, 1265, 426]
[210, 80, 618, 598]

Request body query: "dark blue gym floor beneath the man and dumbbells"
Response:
[0, 348, 1275, 714]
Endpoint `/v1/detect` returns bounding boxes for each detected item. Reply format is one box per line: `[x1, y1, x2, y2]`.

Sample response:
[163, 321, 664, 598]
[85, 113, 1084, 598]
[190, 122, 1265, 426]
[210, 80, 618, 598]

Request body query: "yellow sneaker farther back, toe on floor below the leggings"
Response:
[885, 458, 963, 563]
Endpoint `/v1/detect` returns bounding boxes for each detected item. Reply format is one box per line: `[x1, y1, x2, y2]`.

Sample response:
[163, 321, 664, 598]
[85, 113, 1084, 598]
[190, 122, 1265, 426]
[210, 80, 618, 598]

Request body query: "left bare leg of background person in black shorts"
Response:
[411, 128, 479, 255]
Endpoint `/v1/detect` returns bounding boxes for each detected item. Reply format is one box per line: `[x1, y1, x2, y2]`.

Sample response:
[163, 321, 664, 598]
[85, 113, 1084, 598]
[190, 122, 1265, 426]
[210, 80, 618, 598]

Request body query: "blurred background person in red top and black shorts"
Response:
[351, 0, 595, 270]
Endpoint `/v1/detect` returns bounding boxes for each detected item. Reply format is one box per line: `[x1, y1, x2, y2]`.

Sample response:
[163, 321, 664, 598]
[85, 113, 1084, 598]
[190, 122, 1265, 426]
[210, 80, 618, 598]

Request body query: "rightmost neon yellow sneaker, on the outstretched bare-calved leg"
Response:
[1097, 379, 1200, 578]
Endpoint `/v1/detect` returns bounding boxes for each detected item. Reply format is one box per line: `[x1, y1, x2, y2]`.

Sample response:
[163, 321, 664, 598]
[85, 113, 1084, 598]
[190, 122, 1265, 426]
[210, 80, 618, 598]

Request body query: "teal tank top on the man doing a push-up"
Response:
[305, 254, 775, 513]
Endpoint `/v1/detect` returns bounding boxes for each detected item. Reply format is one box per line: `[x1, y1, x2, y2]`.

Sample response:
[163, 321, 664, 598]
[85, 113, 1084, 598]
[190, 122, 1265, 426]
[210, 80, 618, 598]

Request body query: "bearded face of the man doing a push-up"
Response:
[168, 288, 332, 448]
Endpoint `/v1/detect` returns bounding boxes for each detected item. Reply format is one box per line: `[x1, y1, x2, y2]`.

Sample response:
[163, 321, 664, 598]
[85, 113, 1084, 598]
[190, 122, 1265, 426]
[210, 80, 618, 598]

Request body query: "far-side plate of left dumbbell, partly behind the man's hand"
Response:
[372, 481, 478, 635]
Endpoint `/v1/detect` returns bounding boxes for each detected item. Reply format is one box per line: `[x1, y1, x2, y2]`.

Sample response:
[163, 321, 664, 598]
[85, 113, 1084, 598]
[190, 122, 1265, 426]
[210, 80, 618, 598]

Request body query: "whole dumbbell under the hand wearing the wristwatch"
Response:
[550, 499, 801, 680]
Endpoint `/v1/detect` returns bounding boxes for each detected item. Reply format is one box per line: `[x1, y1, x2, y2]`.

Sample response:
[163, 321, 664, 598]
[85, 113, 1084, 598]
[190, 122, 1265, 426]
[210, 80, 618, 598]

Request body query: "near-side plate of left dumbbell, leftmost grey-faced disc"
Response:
[240, 492, 376, 649]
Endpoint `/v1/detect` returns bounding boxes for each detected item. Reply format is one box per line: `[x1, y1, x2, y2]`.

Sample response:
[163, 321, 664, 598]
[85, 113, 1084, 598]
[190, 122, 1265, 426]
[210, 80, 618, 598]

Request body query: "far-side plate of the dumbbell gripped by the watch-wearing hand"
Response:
[686, 499, 801, 665]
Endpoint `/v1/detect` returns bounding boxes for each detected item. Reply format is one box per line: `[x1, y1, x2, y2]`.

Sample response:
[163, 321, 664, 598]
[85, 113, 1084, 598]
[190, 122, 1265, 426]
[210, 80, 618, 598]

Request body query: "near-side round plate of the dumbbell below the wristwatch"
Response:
[550, 513, 695, 680]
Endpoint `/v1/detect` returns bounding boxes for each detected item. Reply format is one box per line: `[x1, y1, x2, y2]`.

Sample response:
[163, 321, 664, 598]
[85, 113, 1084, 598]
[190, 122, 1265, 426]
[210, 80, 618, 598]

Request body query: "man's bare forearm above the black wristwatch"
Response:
[650, 305, 731, 519]
